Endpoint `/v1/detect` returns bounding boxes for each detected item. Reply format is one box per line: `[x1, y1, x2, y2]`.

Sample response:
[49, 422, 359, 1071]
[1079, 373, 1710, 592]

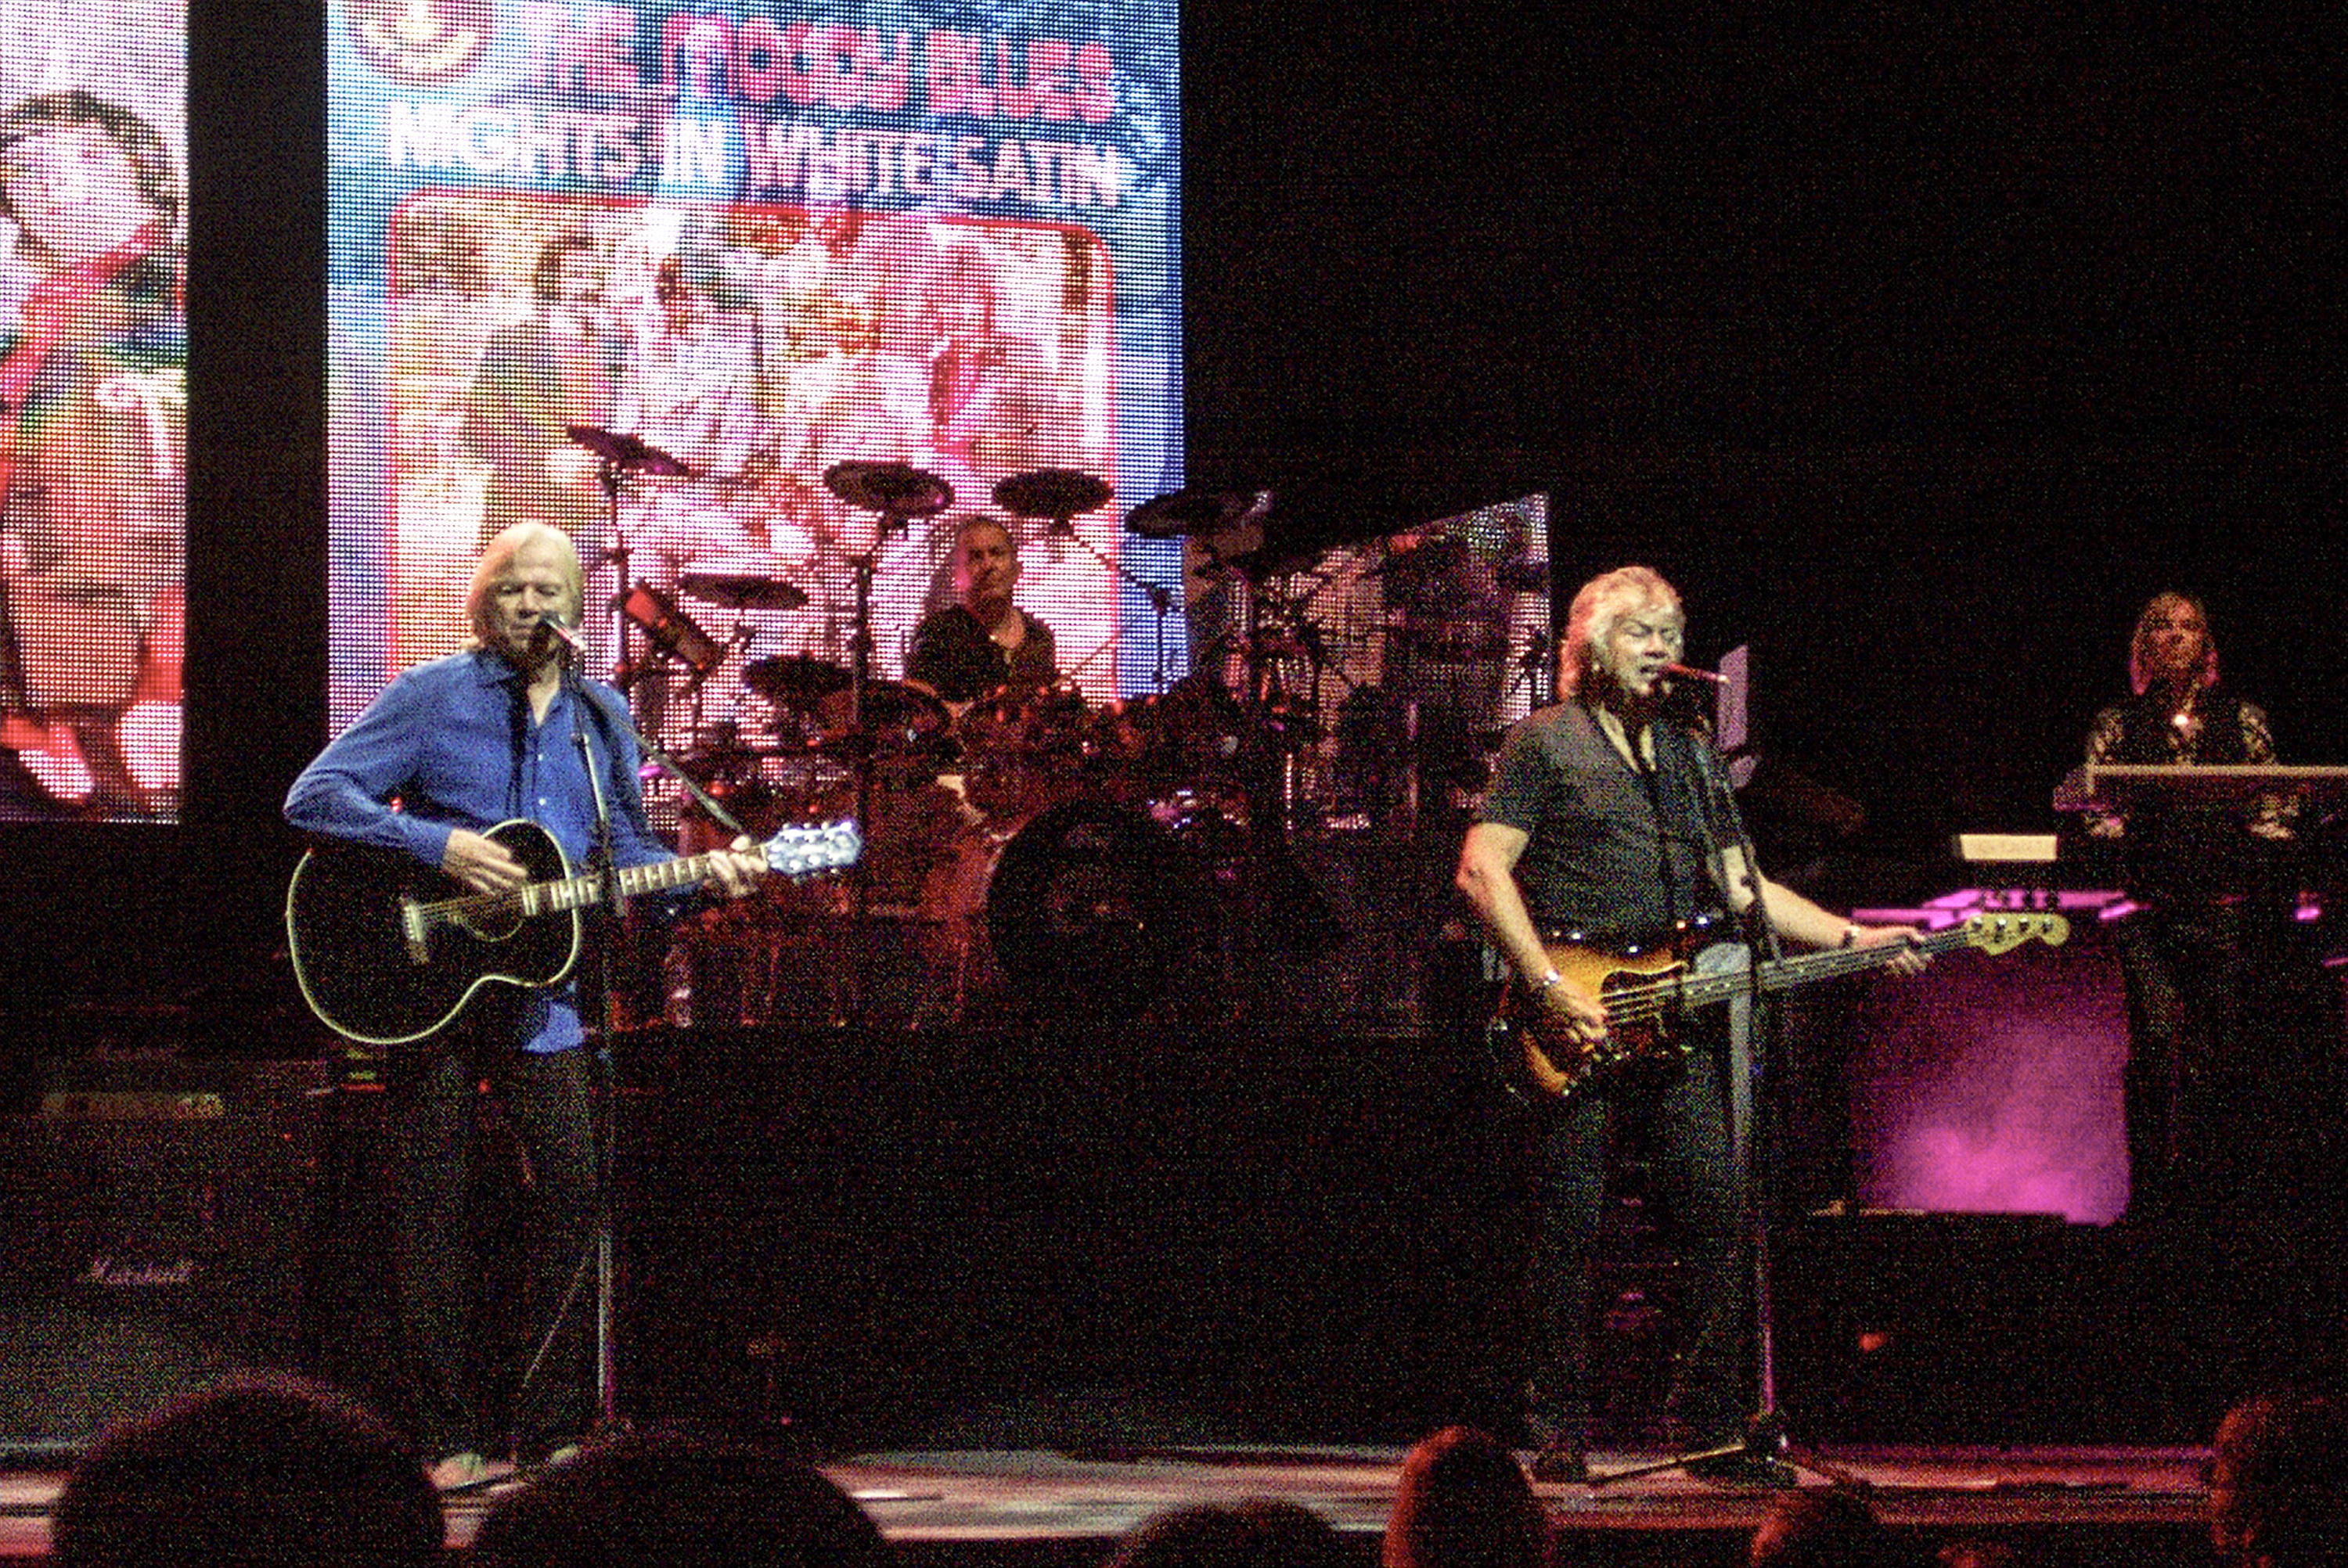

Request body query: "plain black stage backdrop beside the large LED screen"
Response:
[5, 0, 2348, 1080]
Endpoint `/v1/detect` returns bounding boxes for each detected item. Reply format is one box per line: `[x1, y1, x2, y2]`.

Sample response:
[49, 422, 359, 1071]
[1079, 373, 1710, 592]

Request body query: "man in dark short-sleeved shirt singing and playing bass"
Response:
[1458, 566, 1925, 1479]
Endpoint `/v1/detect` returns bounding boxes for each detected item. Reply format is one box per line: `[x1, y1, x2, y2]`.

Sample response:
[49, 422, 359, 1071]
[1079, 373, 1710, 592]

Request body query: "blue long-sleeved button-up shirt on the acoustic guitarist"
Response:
[286, 650, 669, 1052]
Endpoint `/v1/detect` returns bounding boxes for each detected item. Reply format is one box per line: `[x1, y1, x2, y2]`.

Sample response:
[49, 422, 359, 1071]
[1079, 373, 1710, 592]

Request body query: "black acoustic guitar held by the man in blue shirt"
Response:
[286, 819, 864, 1045]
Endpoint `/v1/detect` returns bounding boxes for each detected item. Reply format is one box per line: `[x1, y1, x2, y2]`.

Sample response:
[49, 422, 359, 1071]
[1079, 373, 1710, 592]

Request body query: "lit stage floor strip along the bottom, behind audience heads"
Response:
[0, 1446, 2205, 1563]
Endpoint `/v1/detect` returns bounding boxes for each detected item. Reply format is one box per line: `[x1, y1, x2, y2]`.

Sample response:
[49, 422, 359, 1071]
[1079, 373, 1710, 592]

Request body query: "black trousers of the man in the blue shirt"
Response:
[387, 1045, 596, 1455]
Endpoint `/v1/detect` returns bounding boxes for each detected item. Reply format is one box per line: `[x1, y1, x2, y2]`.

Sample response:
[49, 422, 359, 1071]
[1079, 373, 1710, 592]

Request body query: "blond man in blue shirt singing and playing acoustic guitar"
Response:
[286, 523, 765, 1486]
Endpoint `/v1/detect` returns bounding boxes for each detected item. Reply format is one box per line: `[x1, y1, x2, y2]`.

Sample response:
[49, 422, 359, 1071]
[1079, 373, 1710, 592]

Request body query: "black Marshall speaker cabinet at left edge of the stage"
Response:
[0, 1061, 319, 1462]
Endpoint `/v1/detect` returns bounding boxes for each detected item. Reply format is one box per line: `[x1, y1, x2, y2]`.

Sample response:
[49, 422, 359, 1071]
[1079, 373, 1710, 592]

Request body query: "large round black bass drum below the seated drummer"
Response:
[986, 800, 1216, 1009]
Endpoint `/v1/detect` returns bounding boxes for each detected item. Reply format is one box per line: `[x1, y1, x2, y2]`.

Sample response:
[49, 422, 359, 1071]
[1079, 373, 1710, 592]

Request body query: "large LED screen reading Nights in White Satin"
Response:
[329, 0, 1186, 798]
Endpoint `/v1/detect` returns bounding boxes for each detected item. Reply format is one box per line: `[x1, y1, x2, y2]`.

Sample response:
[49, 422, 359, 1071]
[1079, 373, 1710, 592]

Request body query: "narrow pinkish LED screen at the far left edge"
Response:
[0, 0, 188, 822]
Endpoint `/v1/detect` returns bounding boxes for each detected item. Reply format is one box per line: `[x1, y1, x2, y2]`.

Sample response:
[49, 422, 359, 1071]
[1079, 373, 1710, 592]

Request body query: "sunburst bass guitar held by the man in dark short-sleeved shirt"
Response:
[1496, 911, 2071, 1099]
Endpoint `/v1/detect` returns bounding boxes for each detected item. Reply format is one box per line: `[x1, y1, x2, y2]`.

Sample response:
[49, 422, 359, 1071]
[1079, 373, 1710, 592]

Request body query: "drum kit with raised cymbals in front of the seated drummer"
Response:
[571, 427, 1465, 1023]
